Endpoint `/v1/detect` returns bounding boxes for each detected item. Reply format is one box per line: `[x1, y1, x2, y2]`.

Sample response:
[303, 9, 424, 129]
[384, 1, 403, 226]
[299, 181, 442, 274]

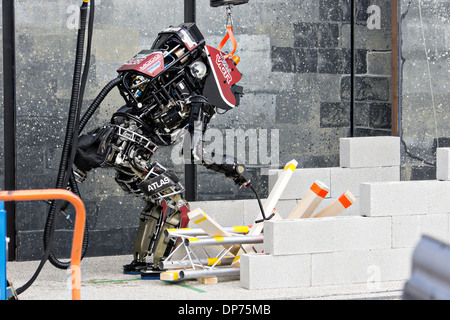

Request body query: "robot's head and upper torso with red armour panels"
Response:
[117, 23, 242, 114]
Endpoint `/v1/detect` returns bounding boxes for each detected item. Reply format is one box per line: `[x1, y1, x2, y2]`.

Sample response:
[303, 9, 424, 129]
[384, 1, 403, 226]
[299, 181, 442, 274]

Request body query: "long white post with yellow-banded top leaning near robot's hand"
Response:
[232, 160, 298, 268]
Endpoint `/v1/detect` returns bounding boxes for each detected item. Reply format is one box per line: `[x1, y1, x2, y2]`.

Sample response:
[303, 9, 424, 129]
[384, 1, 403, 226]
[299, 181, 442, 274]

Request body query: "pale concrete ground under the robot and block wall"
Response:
[7, 255, 404, 301]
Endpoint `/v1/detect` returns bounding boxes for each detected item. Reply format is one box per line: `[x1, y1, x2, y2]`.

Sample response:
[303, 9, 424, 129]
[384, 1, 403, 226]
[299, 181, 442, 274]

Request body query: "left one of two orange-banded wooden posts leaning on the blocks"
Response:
[288, 180, 330, 219]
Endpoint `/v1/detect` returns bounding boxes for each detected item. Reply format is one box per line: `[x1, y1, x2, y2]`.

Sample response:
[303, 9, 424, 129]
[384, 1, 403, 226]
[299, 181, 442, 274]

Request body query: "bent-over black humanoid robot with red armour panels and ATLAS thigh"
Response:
[74, 0, 255, 274]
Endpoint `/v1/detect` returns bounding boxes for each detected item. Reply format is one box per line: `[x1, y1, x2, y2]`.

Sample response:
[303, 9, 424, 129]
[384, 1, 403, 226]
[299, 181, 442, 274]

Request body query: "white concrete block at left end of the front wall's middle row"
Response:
[264, 218, 334, 255]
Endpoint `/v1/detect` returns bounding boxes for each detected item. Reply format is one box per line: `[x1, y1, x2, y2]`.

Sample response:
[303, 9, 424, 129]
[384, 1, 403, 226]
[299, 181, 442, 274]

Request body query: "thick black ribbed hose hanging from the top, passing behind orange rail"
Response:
[44, 2, 88, 269]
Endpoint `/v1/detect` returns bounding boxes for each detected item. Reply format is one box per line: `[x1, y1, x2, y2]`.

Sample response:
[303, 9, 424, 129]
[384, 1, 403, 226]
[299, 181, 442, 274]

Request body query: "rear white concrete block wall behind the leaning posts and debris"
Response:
[190, 137, 400, 226]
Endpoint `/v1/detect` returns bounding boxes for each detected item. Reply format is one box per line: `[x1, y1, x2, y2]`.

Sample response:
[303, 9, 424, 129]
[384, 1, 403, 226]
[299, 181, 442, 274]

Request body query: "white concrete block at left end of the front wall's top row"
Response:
[359, 181, 430, 217]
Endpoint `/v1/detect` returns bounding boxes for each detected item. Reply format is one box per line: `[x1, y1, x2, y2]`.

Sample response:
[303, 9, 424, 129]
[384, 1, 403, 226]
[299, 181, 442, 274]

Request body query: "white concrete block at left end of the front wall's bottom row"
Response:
[240, 254, 311, 290]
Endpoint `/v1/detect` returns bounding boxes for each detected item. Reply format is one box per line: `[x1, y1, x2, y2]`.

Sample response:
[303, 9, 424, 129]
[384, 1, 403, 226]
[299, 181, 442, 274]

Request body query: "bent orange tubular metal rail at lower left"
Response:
[0, 189, 86, 300]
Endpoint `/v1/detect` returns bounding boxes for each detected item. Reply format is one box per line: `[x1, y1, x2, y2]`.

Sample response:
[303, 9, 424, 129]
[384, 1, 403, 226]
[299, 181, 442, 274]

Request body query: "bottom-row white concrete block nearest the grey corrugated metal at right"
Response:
[367, 248, 414, 282]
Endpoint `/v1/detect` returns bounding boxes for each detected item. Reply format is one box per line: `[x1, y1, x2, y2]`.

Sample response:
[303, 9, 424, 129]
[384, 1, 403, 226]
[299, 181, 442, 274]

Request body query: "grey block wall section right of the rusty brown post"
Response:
[400, 0, 450, 180]
